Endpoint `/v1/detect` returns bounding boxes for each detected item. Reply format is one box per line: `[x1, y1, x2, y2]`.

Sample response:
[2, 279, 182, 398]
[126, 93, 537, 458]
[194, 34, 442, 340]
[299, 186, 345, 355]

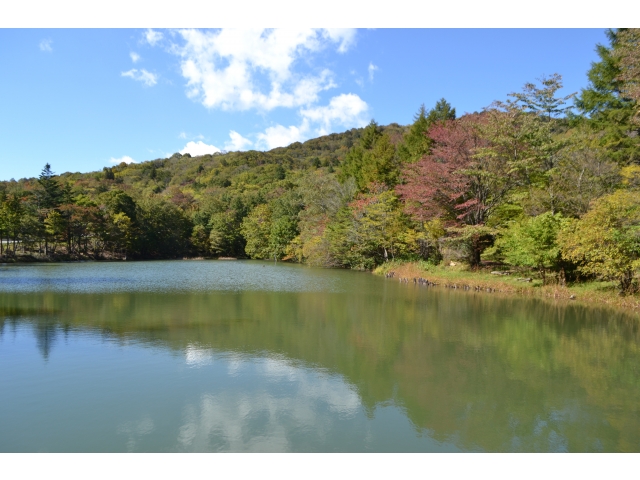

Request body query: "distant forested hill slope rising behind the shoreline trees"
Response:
[0, 123, 408, 203]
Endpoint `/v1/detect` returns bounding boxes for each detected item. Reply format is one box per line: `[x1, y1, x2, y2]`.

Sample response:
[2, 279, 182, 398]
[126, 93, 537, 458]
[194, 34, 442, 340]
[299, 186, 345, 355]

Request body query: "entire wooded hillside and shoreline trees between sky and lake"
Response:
[0, 29, 640, 292]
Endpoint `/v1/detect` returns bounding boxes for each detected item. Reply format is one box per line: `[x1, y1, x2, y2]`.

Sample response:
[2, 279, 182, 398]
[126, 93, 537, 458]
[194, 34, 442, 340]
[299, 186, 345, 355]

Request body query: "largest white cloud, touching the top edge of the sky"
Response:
[170, 29, 355, 110]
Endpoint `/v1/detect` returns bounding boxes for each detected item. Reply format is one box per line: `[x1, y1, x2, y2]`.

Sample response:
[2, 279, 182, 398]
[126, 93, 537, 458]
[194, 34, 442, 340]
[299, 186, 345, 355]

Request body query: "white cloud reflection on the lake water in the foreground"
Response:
[177, 346, 362, 452]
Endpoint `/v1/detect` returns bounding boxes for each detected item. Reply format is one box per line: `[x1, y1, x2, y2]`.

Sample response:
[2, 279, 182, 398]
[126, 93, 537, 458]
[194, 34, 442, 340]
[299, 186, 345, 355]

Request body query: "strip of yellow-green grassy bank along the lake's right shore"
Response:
[373, 261, 640, 313]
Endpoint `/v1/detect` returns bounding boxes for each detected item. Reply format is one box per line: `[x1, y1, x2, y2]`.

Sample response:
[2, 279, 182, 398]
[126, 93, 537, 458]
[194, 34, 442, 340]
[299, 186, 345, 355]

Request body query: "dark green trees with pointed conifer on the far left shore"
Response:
[0, 164, 190, 259]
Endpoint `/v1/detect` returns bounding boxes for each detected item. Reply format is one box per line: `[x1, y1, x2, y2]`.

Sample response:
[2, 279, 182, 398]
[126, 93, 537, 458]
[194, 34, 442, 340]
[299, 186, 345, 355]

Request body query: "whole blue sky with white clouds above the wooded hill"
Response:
[0, 29, 607, 180]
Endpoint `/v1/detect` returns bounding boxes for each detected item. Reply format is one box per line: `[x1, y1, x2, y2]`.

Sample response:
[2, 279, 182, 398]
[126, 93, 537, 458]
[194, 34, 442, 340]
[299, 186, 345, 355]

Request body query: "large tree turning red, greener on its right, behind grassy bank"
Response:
[396, 108, 534, 264]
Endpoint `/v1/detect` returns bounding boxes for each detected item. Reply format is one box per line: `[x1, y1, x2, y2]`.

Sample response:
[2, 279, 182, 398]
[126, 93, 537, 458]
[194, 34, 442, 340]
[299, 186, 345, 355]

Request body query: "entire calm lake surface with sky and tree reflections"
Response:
[0, 261, 640, 452]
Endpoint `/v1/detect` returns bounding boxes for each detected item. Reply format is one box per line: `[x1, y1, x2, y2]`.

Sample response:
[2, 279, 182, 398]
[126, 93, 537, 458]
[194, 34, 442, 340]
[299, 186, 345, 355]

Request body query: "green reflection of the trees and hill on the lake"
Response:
[0, 262, 640, 452]
